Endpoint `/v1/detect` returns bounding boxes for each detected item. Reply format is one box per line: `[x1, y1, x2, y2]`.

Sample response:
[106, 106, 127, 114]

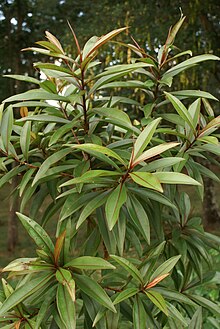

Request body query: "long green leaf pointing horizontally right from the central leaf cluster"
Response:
[152, 171, 201, 186]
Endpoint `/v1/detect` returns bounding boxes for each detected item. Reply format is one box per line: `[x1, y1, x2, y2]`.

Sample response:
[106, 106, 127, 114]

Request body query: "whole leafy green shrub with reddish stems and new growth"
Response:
[0, 17, 220, 329]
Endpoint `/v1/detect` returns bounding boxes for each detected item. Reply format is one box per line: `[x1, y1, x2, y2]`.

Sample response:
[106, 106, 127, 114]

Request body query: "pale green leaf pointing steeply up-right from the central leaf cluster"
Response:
[132, 118, 161, 162]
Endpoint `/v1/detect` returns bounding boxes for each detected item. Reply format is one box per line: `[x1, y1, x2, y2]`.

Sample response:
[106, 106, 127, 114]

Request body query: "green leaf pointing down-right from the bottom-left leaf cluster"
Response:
[74, 274, 116, 312]
